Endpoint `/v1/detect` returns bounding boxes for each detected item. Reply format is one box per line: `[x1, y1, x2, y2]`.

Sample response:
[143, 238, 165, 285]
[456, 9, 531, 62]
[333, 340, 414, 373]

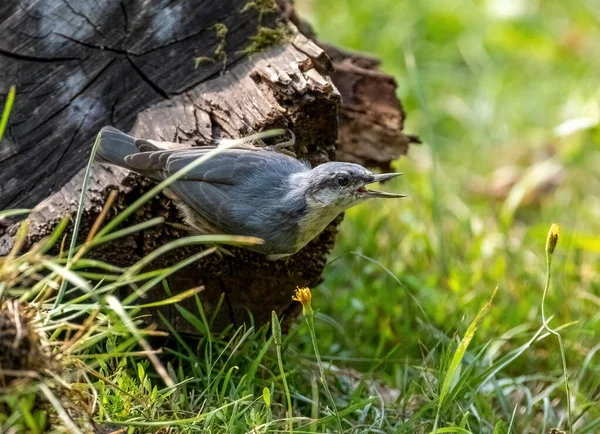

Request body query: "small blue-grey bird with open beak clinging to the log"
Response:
[96, 127, 405, 260]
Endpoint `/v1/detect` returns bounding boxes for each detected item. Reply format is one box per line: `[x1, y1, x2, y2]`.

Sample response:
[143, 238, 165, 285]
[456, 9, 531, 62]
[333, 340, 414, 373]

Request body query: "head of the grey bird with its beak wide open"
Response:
[306, 162, 404, 209]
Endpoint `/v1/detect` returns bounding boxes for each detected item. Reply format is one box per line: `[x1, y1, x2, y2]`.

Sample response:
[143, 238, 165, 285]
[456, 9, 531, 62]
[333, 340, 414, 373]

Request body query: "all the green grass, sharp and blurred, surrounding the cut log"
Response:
[0, 0, 600, 434]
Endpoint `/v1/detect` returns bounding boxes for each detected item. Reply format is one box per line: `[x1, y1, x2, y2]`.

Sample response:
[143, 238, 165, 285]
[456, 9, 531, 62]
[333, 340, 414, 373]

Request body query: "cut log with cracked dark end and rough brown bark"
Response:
[0, 0, 413, 331]
